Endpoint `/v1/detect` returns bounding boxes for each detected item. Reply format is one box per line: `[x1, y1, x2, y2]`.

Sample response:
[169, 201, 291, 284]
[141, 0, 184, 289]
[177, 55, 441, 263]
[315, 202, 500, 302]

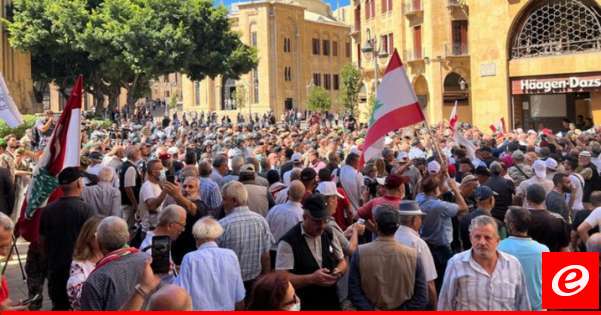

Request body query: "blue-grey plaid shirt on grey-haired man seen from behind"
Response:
[217, 206, 274, 281]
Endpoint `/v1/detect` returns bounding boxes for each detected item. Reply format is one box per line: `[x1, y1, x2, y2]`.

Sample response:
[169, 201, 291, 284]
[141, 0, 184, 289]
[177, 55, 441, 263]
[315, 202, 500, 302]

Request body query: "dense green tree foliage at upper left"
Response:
[4, 0, 257, 110]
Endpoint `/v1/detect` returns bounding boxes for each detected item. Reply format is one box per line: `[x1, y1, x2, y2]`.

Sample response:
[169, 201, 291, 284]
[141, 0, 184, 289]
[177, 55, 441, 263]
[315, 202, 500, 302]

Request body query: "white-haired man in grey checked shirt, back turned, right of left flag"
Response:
[81, 166, 122, 217]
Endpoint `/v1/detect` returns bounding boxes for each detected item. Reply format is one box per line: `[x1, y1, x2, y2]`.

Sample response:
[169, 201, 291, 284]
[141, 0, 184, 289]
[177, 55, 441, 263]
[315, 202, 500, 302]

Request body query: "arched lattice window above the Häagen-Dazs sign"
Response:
[511, 0, 601, 59]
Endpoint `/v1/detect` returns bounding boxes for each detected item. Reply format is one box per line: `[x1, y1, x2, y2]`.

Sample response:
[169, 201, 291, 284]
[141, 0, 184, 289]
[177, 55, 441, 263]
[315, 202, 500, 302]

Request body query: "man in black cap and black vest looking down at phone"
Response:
[275, 194, 347, 310]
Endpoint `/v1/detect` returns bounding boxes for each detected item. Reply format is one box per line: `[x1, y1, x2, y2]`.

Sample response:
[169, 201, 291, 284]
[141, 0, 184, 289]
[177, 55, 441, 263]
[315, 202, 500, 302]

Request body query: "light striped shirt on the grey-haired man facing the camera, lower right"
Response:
[438, 249, 530, 311]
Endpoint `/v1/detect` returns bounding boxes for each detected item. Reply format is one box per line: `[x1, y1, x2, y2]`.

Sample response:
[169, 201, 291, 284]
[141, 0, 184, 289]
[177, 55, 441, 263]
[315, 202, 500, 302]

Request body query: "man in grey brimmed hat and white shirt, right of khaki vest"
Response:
[394, 200, 438, 308]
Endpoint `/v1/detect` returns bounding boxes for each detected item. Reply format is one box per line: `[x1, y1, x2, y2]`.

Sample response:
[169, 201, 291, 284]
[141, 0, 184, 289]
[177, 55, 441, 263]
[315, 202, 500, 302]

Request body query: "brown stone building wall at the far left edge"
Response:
[0, 0, 34, 113]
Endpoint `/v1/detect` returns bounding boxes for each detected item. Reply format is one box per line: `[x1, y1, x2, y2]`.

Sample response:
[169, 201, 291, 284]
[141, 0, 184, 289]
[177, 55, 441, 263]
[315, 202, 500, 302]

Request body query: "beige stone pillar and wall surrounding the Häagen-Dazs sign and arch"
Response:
[468, 0, 601, 129]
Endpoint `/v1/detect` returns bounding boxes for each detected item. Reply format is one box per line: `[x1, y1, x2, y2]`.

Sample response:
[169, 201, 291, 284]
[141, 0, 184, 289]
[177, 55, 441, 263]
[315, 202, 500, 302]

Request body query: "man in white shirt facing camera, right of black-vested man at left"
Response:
[138, 160, 167, 231]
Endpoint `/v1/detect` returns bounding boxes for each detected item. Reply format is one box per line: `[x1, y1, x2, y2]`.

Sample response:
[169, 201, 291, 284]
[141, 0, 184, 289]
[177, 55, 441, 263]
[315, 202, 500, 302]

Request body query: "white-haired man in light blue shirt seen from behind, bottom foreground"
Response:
[176, 217, 245, 311]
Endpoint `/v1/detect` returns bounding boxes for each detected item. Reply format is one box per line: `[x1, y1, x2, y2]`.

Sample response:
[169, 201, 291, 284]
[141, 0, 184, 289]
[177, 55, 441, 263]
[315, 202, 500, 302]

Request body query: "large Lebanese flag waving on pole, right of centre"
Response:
[360, 49, 425, 165]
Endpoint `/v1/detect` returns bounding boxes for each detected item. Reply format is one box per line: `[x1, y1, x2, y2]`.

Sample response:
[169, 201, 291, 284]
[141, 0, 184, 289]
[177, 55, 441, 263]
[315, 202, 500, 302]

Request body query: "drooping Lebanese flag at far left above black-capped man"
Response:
[25, 76, 83, 219]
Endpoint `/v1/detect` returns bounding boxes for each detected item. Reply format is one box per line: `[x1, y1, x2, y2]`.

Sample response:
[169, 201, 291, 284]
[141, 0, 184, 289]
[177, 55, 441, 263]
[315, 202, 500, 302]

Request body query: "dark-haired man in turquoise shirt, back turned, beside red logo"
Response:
[498, 207, 549, 310]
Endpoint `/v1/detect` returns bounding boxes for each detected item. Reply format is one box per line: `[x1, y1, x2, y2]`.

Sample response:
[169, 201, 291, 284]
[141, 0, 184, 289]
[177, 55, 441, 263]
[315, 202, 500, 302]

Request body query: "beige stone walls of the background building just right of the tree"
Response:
[182, 0, 352, 117]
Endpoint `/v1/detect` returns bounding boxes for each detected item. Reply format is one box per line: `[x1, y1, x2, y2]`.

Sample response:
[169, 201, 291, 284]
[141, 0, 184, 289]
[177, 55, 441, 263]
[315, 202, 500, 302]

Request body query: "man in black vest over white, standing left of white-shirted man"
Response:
[119, 145, 142, 229]
